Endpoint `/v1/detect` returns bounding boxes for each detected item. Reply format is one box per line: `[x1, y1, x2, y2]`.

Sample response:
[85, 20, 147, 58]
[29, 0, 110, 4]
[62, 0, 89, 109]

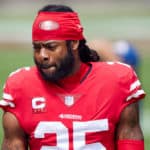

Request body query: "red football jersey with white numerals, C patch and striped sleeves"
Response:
[0, 62, 145, 150]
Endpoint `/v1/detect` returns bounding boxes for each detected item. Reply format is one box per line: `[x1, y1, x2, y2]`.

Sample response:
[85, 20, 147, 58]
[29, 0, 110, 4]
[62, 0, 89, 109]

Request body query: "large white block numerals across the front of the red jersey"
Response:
[34, 119, 109, 150]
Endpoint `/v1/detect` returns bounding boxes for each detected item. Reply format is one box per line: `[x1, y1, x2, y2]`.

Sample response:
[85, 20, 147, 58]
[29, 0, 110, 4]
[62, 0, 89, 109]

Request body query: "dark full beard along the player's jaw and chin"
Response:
[34, 41, 75, 82]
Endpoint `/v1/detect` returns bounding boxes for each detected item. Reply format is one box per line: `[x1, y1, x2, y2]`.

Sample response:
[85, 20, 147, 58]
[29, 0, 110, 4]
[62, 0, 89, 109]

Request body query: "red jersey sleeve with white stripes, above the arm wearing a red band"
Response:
[116, 64, 146, 118]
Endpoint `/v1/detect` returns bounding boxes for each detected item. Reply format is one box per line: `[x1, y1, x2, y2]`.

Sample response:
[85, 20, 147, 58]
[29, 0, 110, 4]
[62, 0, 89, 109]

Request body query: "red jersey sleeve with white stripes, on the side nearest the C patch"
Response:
[0, 67, 29, 112]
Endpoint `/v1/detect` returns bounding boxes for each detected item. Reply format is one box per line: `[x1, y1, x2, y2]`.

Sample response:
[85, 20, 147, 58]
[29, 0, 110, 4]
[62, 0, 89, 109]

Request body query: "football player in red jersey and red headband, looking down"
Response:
[0, 5, 145, 150]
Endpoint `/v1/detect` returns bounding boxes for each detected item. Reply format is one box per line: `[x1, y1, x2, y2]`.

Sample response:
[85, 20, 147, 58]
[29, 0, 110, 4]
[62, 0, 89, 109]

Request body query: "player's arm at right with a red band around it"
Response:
[116, 103, 144, 150]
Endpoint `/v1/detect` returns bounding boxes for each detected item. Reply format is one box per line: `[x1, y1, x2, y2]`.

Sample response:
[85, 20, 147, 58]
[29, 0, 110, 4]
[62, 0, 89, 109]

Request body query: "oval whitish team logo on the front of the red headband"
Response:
[39, 20, 59, 31]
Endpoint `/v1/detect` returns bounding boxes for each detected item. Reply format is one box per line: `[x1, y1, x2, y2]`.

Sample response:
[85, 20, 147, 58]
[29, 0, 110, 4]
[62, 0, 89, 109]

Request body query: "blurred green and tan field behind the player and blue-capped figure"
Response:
[0, 0, 150, 150]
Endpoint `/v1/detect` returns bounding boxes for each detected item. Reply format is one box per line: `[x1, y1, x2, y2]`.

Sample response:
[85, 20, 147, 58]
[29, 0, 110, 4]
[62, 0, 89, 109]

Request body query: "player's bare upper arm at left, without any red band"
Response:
[2, 112, 28, 150]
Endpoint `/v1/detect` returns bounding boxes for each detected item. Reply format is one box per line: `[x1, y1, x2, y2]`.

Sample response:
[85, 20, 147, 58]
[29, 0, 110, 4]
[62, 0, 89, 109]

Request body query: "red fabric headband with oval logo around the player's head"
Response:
[32, 12, 84, 41]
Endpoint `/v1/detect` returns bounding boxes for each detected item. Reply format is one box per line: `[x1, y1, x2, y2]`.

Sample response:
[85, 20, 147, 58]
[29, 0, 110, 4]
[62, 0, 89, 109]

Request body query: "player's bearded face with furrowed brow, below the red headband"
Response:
[33, 40, 75, 82]
